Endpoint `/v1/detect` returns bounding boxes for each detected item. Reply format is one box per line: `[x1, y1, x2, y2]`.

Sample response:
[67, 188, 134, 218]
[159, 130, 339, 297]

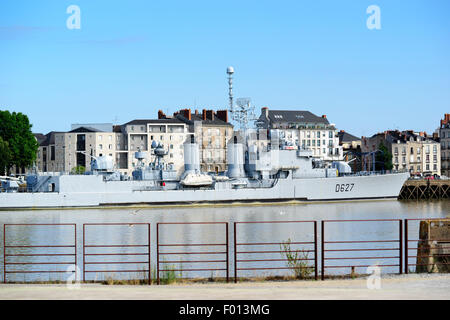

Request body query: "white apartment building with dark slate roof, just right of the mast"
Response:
[256, 107, 343, 161]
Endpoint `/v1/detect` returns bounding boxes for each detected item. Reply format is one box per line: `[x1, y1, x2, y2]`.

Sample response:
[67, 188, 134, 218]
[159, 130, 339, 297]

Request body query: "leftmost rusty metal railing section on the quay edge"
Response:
[3, 223, 77, 283]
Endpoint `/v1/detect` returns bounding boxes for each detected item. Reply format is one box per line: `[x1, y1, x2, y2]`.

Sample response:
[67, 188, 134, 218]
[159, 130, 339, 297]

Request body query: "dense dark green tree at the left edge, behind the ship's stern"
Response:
[0, 110, 39, 175]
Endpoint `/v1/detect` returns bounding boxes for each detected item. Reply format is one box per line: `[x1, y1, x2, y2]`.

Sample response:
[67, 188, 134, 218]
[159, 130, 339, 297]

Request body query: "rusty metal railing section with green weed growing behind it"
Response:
[234, 221, 318, 283]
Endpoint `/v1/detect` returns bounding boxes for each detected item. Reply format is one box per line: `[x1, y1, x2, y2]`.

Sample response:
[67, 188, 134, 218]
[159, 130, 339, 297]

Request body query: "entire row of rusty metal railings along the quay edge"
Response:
[0, 218, 450, 284]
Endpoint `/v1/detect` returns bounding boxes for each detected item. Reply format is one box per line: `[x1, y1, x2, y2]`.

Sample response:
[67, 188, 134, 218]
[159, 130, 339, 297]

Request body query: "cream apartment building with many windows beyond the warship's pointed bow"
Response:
[361, 130, 441, 175]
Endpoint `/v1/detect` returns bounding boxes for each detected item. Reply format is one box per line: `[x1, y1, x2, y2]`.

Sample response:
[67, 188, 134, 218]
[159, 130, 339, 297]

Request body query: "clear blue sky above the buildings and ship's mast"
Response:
[0, 0, 450, 136]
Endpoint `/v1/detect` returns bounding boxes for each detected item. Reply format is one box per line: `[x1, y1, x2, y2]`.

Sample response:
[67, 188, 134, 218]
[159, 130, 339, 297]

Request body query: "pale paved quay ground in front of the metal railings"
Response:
[0, 274, 450, 300]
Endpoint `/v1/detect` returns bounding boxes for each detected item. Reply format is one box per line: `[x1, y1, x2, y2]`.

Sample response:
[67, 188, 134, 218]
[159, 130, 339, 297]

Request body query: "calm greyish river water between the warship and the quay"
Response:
[0, 200, 450, 281]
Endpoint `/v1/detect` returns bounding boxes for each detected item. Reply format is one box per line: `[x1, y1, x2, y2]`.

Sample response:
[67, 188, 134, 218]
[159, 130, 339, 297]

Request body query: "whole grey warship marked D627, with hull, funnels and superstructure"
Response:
[0, 136, 409, 210]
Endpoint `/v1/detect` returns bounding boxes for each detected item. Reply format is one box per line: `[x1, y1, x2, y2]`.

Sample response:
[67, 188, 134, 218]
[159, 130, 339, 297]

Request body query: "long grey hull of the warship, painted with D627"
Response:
[0, 173, 409, 210]
